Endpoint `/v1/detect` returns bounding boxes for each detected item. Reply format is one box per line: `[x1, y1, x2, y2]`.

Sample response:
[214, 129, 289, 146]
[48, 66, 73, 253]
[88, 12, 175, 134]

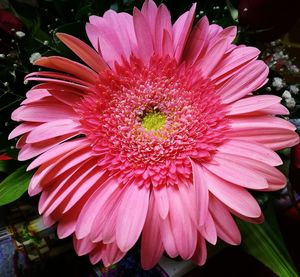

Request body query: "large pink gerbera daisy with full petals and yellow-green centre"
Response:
[10, 0, 299, 269]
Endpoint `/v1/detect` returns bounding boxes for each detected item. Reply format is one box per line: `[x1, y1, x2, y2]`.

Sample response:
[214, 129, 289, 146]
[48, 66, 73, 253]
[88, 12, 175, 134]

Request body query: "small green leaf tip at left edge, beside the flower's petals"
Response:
[0, 166, 32, 206]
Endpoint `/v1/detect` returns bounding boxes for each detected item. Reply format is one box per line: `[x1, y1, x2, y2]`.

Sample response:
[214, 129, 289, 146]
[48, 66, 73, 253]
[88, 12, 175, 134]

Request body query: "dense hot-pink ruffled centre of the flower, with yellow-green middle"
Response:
[78, 56, 227, 186]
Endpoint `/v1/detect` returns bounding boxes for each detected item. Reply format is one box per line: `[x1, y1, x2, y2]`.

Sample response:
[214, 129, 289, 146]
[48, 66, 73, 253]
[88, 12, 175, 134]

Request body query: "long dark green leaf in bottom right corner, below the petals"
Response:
[238, 202, 299, 277]
